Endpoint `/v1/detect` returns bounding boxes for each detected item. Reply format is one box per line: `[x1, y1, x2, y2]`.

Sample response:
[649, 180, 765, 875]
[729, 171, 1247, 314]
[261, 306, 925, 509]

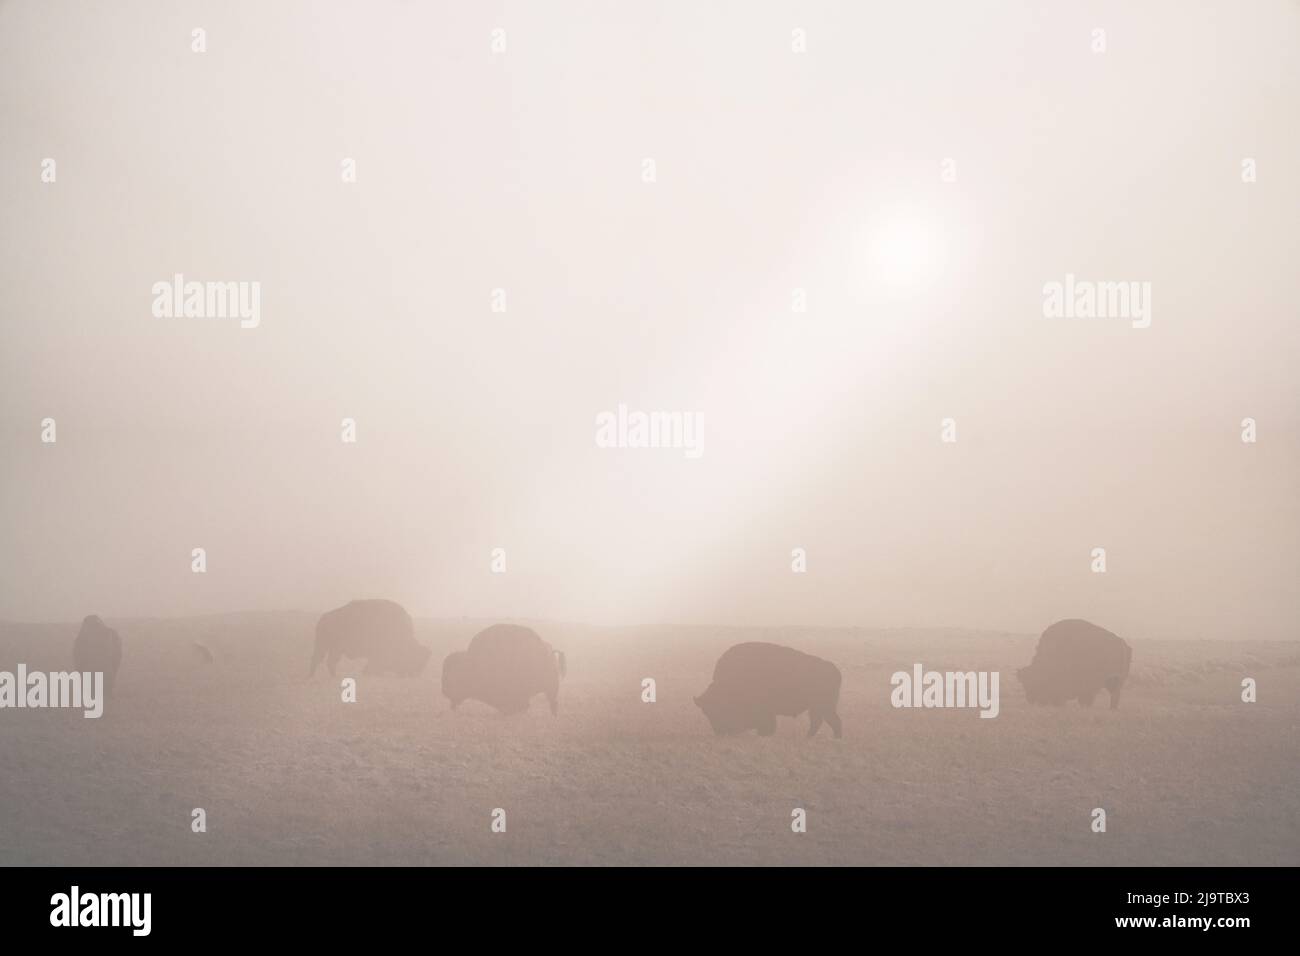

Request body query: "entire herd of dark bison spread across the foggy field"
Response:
[65, 600, 1132, 737]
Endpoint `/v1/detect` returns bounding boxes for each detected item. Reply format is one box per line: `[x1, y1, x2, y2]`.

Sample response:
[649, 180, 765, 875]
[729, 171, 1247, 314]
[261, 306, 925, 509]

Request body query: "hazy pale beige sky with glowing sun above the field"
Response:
[0, 0, 1300, 639]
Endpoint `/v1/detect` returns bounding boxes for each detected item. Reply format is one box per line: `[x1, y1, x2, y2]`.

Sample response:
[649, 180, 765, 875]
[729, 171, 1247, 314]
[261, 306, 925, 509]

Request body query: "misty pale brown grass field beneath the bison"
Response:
[0, 613, 1300, 865]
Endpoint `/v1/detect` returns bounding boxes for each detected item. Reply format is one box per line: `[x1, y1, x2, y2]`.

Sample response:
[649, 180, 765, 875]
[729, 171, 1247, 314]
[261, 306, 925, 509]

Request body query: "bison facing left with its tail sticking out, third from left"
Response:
[442, 624, 566, 714]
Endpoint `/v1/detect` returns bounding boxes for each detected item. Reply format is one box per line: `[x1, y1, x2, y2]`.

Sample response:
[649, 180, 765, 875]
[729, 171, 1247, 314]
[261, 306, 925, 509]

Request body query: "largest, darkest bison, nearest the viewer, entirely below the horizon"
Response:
[696, 641, 841, 736]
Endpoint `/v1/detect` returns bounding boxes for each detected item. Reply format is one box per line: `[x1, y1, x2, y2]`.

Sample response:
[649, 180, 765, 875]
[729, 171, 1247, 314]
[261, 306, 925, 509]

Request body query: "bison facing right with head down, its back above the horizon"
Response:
[308, 601, 433, 678]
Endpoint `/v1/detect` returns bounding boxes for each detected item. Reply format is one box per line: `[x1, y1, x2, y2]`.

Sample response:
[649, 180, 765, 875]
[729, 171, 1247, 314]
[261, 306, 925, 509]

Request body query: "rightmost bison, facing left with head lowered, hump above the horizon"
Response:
[1015, 619, 1134, 710]
